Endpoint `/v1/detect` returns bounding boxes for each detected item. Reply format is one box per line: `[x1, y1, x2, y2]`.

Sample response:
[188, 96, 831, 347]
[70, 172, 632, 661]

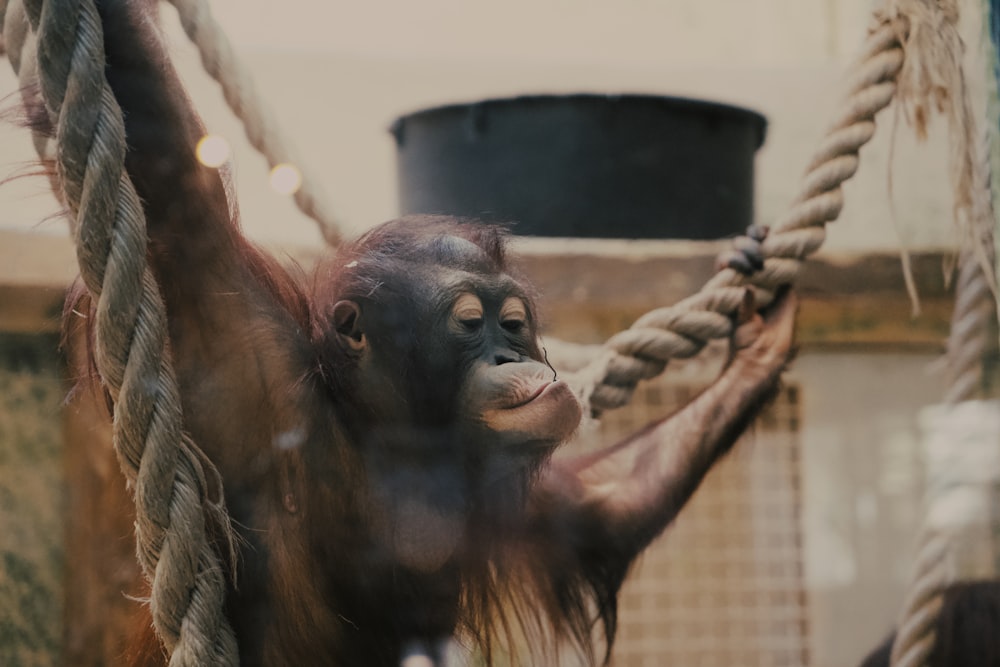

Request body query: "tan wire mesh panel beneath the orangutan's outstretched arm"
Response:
[568, 353, 808, 667]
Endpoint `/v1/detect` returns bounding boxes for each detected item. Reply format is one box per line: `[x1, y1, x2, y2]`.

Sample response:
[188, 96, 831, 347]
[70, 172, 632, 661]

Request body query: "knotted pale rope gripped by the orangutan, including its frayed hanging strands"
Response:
[574, 0, 992, 414]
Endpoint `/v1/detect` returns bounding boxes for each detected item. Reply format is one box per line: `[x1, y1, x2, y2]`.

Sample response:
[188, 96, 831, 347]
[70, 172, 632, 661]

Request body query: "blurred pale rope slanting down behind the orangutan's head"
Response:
[164, 0, 343, 246]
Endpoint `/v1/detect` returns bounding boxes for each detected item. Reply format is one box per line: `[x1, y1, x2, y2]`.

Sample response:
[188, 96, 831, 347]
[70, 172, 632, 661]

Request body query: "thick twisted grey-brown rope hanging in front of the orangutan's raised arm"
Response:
[4, 0, 238, 667]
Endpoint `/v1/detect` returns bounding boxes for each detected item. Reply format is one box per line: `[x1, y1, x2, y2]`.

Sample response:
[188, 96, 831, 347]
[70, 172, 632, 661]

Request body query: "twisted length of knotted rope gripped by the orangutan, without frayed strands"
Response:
[574, 20, 906, 413]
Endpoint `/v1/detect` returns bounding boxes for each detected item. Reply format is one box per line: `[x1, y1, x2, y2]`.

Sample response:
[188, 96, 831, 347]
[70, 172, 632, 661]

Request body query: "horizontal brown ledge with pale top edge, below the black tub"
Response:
[0, 231, 952, 350]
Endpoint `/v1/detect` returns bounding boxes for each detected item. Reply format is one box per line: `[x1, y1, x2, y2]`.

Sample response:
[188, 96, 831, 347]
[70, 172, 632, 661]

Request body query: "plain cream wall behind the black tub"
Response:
[0, 0, 976, 248]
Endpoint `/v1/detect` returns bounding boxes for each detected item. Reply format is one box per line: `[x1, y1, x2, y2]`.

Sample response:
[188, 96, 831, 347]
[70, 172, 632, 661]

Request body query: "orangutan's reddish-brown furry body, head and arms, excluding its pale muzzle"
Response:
[43, 0, 795, 665]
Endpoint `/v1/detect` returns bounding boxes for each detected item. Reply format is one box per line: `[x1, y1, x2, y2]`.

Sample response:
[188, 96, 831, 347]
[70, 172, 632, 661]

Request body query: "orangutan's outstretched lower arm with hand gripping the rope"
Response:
[535, 292, 796, 562]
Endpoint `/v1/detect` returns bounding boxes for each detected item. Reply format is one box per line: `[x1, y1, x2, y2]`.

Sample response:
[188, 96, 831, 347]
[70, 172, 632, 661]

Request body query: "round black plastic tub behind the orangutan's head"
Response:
[392, 95, 767, 239]
